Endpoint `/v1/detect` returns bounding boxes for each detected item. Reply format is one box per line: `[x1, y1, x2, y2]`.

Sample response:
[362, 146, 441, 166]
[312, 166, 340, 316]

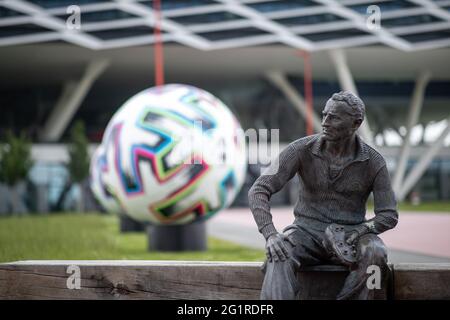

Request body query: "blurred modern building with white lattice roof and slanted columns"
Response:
[0, 0, 450, 212]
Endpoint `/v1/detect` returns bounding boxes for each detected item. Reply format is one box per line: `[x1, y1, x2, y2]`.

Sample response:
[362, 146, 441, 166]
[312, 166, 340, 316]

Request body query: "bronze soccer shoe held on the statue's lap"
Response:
[324, 223, 357, 266]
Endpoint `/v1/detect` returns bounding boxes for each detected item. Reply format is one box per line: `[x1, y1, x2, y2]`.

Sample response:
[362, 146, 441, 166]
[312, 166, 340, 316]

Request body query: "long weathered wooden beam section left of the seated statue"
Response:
[0, 261, 262, 299]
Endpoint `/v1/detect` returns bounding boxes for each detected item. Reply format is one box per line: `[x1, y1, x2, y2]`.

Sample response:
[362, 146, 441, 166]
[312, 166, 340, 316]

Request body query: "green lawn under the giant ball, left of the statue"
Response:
[0, 213, 264, 262]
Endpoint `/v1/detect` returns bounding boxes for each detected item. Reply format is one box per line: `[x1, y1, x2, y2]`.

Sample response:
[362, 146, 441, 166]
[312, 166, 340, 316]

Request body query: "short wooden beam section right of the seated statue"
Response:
[393, 263, 450, 300]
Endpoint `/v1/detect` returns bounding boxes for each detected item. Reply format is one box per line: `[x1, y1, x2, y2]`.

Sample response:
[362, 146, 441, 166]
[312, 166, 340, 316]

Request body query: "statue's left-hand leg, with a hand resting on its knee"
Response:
[261, 227, 321, 300]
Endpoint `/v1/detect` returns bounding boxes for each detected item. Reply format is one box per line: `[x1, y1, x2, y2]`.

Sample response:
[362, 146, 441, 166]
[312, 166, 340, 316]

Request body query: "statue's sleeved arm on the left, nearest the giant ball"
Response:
[248, 143, 300, 240]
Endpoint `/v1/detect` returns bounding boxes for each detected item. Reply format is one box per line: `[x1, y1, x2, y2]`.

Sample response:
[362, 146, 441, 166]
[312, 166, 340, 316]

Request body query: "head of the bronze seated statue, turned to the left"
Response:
[322, 91, 365, 141]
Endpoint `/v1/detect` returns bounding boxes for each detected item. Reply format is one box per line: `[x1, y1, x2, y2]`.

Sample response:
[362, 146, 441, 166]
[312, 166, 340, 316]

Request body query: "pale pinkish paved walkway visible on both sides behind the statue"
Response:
[208, 208, 450, 263]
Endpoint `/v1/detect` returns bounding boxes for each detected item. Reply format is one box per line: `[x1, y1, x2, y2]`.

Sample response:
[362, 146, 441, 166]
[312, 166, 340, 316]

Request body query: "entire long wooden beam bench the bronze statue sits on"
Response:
[0, 260, 450, 300]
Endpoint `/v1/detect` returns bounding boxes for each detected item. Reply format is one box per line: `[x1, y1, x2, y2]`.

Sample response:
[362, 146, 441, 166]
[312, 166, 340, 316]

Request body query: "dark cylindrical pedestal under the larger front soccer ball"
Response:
[147, 221, 207, 252]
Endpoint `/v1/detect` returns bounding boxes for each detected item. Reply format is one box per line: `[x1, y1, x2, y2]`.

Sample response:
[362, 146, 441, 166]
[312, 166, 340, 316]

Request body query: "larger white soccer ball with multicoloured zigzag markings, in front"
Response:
[94, 84, 246, 225]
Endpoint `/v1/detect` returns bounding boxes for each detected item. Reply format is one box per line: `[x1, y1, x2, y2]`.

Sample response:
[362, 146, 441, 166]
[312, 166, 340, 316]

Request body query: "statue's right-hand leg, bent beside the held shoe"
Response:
[337, 234, 389, 300]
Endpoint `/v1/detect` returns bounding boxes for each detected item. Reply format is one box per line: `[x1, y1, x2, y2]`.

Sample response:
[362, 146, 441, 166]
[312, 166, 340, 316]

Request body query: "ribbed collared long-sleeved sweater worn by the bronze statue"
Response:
[249, 134, 398, 238]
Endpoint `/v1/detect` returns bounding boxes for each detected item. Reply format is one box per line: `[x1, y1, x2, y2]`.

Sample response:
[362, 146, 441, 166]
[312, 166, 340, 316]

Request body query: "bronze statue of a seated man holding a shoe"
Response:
[249, 91, 398, 299]
